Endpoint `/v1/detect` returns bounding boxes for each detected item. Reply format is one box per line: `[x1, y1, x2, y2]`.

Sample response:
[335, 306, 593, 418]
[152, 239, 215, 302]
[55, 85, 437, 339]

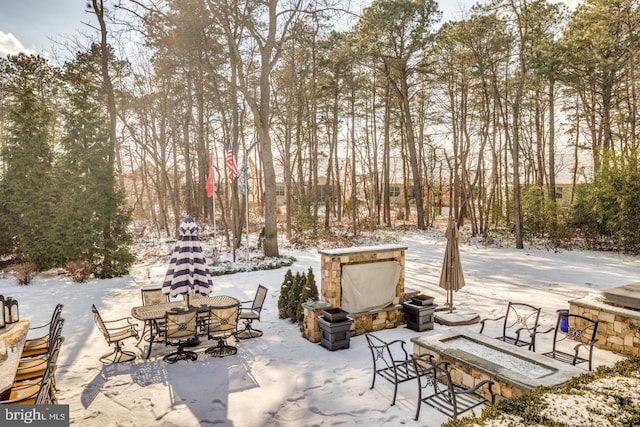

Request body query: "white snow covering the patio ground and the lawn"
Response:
[0, 229, 640, 427]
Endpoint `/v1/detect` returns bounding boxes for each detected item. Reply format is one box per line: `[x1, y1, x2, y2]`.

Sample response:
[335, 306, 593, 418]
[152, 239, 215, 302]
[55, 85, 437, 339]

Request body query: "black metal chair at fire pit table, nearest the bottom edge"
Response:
[411, 354, 495, 421]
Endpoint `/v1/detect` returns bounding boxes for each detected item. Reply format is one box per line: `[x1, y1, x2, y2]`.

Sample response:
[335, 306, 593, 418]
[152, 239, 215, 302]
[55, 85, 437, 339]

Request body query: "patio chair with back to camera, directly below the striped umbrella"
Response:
[163, 310, 198, 363]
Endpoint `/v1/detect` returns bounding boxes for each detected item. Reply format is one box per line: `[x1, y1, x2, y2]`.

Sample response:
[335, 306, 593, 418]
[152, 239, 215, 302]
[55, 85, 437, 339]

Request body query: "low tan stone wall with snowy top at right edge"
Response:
[569, 296, 640, 356]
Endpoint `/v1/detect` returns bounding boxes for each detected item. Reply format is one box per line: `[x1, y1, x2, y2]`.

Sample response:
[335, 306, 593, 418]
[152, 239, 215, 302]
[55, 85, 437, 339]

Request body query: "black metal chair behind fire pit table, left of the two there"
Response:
[480, 301, 540, 352]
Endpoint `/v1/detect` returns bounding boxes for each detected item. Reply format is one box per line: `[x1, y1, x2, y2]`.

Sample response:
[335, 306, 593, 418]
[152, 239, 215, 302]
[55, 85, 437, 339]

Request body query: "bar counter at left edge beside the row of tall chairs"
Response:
[0, 317, 31, 397]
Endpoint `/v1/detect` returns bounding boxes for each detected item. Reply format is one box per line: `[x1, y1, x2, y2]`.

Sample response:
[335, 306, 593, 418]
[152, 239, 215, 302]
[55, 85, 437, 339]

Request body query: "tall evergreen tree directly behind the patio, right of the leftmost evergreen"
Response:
[56, 44, 134, 278]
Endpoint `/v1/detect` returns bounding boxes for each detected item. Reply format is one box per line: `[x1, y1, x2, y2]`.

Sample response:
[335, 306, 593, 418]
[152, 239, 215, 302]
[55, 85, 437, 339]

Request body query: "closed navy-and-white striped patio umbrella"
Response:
[162, 216, 213, 298]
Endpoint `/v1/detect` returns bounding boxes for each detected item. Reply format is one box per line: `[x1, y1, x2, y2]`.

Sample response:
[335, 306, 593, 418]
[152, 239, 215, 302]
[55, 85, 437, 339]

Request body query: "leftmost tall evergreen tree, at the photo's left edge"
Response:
[0, 53, 60, 270]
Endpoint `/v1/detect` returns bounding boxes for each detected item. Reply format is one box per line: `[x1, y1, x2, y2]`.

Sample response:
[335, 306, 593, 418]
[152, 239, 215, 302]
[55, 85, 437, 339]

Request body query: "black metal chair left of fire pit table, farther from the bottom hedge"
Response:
[365, 334, 416, 406]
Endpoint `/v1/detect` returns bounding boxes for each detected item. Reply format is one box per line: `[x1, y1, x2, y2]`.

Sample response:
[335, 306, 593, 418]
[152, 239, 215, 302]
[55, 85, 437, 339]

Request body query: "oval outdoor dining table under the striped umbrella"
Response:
[131, 295, 240, 359]
